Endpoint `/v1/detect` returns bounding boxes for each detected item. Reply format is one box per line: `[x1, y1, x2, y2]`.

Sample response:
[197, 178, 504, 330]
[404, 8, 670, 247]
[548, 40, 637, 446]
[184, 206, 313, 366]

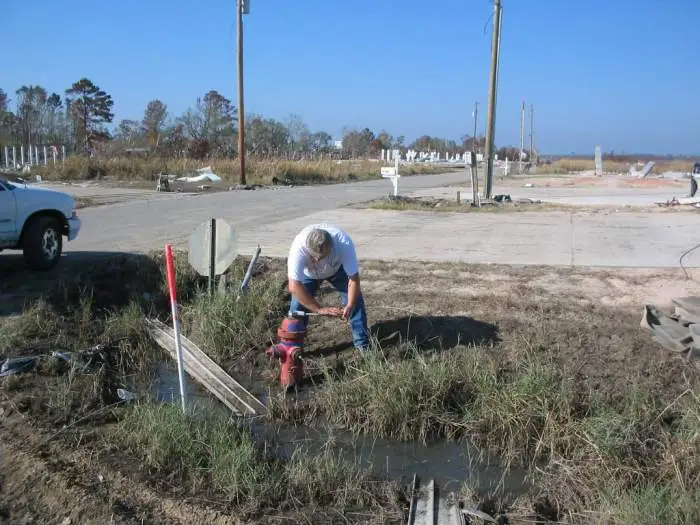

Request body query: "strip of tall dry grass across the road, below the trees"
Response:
[32, 156, 450, 184]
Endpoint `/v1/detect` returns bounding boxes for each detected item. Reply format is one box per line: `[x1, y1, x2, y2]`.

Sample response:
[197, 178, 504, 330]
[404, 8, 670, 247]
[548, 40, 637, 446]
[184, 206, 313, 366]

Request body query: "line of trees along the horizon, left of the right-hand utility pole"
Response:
[0, 78, 506, 159]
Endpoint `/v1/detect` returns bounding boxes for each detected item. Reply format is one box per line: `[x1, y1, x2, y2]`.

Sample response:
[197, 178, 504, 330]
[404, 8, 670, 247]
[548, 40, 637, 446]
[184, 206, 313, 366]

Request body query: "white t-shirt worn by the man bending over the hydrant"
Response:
[287, 223, 358, 281]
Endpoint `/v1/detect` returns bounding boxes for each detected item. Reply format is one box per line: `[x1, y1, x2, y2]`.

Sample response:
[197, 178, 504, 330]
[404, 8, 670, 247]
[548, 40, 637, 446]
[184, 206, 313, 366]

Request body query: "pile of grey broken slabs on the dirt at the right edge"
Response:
[640, 296, 700, 366]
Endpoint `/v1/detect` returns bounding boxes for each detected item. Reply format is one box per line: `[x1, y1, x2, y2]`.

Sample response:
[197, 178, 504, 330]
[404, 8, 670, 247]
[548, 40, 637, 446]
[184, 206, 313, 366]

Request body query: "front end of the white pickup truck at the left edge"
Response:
[0, 176, 80, 270]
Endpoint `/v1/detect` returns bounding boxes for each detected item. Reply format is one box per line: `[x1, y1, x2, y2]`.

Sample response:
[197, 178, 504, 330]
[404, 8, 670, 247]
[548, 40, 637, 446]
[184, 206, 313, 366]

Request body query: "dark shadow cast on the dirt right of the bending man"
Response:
[370, 316, 500, 351]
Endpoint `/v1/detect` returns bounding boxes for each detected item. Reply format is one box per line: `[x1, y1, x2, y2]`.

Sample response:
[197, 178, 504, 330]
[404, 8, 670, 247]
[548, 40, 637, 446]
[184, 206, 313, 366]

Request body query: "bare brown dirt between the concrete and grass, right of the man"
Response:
[300, 262, 700, 398]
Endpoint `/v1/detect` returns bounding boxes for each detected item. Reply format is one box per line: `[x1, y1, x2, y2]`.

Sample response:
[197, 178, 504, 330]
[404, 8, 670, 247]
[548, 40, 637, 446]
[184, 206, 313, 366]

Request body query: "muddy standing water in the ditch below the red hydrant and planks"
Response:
[153, 364, 529, 497]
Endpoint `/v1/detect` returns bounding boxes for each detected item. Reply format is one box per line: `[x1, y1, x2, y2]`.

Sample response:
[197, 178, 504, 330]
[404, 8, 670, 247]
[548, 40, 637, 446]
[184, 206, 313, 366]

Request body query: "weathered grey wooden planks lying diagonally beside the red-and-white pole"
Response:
[147, 319, 267, 415]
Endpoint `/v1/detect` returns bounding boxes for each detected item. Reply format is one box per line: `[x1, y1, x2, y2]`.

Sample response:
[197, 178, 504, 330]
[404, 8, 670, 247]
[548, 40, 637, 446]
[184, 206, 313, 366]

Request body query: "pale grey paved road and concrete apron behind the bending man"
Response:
[67, 173, 700, 267]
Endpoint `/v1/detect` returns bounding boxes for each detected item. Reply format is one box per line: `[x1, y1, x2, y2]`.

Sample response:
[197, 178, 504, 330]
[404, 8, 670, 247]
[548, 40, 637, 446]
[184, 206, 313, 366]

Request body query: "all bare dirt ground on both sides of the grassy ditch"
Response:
[0, 256, 700, 525]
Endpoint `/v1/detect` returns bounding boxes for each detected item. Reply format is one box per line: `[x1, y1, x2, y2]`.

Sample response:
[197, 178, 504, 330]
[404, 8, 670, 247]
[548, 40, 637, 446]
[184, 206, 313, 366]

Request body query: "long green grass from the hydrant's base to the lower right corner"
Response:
[269, 336, 700, 524]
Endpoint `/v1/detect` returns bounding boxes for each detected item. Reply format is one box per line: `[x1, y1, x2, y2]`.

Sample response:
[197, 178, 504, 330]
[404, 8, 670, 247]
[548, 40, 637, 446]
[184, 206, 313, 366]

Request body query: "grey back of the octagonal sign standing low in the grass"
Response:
[187, 219, 238, 276]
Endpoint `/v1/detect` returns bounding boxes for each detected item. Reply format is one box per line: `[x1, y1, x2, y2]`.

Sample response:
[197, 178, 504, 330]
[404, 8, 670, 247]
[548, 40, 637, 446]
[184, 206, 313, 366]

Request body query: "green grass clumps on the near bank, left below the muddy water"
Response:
[107, 404, 401, 523]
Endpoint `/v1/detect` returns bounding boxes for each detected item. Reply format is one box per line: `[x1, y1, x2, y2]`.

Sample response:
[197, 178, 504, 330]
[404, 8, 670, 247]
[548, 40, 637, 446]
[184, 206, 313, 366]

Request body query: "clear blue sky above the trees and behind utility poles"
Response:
[0, 0, 700, 154]
